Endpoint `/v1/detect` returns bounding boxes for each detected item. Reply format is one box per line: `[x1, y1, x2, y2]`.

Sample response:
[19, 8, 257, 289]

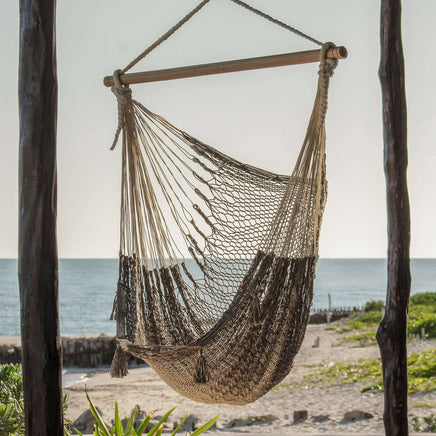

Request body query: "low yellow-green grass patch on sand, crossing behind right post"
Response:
[300, 348, 436, 394]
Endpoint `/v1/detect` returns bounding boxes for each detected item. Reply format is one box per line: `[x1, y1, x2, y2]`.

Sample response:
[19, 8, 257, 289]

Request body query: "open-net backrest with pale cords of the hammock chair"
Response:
[110, 89, 322, 346]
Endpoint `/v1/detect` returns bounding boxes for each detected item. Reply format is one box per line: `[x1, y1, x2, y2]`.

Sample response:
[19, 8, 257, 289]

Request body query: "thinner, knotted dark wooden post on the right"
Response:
[377, 0, 410, 436]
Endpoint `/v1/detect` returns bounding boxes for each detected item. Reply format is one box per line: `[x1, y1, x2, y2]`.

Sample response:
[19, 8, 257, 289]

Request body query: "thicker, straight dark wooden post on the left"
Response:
[18, 0, 63, 436]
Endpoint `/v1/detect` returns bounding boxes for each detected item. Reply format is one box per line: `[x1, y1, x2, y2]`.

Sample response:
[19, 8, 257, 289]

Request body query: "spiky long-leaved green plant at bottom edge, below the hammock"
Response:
[76, 393, 218, 436]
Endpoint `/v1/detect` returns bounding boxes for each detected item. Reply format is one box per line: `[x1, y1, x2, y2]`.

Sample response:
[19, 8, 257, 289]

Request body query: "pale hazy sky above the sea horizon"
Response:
[0, 0, 436, 258]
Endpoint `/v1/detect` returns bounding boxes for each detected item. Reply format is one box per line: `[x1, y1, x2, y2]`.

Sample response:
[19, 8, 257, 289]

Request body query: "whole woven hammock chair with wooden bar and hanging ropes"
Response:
[104, 0, 346, 405]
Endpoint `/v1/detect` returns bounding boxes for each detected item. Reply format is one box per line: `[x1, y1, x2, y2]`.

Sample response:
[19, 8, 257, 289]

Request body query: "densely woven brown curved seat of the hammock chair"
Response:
[115, 255, 315, 405]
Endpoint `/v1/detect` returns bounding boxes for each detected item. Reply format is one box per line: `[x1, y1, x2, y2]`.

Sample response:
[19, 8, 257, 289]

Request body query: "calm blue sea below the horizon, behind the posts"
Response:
[0, 259, 436, 336]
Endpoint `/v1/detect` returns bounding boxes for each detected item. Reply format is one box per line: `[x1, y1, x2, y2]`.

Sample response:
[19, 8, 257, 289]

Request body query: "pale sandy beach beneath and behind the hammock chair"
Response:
[58, 324, 436, 435]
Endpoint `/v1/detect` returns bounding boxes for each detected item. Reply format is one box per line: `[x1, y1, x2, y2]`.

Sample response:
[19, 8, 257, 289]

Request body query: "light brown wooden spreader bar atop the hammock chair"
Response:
[103, 46, 348, 86]
